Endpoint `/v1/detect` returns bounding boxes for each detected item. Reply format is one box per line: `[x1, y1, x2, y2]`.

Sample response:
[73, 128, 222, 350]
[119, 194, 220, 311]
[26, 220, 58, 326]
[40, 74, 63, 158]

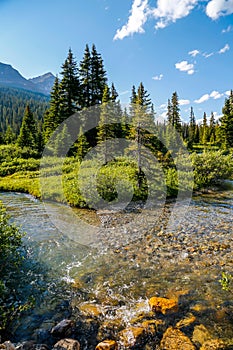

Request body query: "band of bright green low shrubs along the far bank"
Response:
[0, 151, 233, 208]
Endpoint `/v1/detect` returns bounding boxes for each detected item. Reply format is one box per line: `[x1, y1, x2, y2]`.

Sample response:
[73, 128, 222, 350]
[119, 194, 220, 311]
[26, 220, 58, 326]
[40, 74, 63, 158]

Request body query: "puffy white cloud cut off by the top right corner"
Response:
[206, 0, 233, 20]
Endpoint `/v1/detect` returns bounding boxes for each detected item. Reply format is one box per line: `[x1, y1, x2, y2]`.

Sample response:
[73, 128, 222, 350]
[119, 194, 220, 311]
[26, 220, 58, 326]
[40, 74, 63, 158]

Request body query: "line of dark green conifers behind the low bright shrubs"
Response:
[0, 45, 233, 157]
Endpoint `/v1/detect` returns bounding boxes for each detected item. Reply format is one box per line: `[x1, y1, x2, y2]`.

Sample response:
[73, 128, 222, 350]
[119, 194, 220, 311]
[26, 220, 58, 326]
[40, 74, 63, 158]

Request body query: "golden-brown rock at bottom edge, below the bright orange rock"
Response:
[160, 327, 196, 350]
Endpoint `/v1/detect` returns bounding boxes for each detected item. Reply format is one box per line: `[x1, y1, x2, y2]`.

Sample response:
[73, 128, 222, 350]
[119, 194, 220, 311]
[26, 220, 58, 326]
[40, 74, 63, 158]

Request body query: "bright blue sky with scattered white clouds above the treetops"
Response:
[0, 0, 233, 121]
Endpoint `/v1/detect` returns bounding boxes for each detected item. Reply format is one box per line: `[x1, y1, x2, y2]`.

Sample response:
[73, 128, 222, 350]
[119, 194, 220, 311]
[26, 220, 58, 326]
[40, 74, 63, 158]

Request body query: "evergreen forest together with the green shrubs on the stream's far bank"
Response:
[0, 45, 233, 207]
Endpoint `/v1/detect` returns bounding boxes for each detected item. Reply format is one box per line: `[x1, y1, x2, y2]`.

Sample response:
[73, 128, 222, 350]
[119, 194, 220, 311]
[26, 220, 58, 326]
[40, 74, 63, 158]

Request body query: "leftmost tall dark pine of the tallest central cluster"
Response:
[59, 49, 81, 123]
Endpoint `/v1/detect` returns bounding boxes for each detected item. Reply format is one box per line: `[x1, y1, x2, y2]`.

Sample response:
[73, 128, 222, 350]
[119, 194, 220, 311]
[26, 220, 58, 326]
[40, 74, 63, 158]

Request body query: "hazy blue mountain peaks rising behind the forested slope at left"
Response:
[0, 62, 55, 95]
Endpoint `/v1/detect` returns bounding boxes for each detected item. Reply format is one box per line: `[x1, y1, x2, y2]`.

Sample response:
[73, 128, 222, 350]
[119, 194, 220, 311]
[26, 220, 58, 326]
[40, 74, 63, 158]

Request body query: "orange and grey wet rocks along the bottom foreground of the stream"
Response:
[0, 290, 233, 350]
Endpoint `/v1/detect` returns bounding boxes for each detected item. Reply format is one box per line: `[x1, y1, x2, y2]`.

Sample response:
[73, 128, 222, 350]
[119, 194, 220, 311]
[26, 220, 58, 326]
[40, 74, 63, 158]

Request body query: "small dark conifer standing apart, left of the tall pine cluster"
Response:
[17, 105, 37, 149]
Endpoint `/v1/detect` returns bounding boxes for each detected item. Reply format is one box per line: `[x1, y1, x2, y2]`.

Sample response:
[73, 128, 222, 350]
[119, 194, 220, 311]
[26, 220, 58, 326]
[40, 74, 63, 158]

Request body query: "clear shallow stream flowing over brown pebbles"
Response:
[0, 187, 233, 349]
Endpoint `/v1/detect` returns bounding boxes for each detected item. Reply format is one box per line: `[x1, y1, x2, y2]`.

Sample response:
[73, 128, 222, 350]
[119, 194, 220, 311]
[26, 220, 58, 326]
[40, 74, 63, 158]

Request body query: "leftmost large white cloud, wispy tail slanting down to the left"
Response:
[114, 0, 149, 40]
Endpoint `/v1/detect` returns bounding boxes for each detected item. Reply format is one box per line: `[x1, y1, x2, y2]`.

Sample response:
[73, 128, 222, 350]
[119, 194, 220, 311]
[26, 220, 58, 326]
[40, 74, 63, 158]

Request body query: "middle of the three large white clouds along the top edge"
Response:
[151, 0, 198, 29]
